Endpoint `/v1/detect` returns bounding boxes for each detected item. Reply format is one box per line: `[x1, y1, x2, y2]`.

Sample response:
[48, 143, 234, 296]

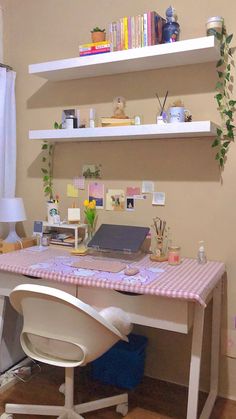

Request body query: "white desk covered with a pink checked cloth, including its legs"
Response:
[0, 249, 225, 419]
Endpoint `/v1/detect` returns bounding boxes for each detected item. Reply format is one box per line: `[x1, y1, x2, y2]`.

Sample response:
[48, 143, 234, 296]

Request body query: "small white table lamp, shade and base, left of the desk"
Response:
[0, 198, 26, 243]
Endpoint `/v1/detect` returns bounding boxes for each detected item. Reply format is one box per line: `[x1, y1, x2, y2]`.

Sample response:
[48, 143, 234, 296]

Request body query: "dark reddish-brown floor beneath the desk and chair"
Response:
[0, 367, 236, 419]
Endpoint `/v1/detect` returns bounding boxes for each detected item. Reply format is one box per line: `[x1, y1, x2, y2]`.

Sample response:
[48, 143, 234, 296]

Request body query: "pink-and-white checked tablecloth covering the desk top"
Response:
[0, 248, 225, 306]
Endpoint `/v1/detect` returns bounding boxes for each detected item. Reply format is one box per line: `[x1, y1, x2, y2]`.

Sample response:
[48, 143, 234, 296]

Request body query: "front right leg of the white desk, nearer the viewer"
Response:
[187, 303, 205, 419]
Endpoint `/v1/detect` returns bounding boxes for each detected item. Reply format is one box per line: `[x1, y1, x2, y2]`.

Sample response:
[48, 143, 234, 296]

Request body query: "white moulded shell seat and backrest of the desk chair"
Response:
[10, 284, 128, 367]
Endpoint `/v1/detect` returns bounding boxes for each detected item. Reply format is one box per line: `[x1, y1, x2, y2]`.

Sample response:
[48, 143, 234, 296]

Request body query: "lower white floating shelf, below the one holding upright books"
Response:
[29, 121, 217, 142]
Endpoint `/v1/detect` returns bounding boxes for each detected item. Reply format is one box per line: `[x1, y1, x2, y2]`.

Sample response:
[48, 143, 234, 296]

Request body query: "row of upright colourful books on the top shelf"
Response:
[109, 11, 166, 51]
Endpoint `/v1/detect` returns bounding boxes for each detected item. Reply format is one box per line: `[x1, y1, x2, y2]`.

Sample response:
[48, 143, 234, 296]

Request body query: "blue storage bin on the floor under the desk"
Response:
[91, 333, 147, 390]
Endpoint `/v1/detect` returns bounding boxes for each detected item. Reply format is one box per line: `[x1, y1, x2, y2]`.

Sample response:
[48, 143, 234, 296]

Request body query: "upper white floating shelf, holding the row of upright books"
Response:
[29, 36, 220, 81]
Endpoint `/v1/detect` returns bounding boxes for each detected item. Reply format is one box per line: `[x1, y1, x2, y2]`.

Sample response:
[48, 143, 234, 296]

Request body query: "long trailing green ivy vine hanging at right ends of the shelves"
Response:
[212, 25, 236, 168]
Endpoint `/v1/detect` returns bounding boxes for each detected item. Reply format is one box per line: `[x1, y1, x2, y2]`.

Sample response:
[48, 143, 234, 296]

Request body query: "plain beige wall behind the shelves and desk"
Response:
[2, 0, 236, 398]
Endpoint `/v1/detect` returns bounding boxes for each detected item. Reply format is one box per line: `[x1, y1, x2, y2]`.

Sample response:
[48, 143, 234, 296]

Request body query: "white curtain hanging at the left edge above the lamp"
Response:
[0, 68, 16, 198]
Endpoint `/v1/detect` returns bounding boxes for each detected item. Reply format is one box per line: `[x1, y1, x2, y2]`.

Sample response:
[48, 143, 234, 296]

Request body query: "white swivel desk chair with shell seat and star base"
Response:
[1, 284, 128, 419]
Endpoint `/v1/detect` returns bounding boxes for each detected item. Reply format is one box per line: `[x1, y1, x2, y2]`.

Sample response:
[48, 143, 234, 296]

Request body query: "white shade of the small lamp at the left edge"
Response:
[0, 198, 26, 223]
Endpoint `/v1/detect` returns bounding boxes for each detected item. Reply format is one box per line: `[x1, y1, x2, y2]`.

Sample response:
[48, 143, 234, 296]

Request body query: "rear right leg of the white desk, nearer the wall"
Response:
[199, 281, 222, 419]
